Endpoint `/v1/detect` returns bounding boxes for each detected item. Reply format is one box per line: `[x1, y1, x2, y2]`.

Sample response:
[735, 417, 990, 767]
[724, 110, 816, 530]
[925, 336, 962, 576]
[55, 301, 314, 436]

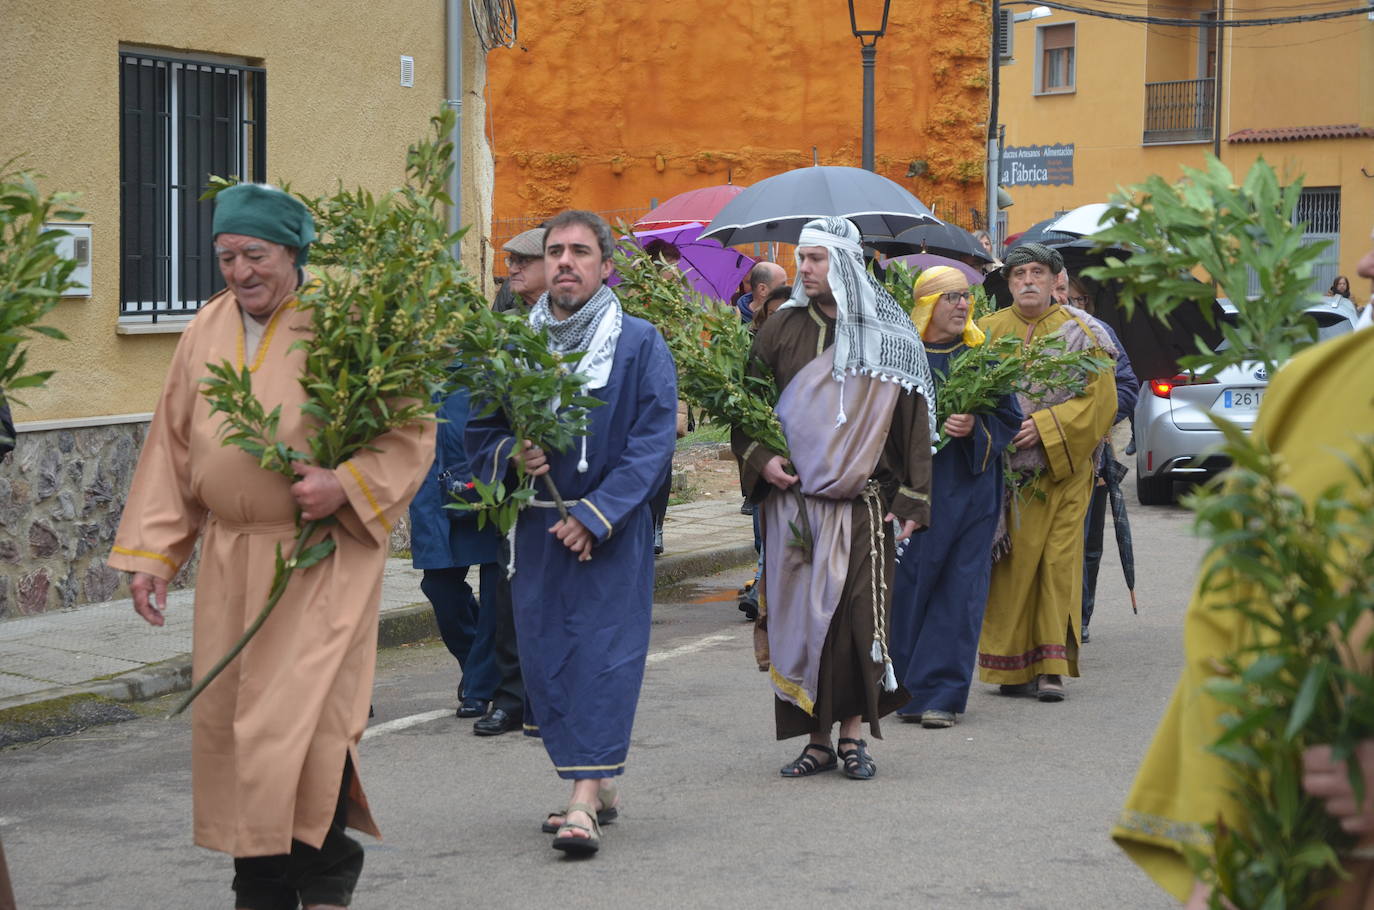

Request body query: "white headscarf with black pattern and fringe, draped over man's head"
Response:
[779, 217, 936, 441]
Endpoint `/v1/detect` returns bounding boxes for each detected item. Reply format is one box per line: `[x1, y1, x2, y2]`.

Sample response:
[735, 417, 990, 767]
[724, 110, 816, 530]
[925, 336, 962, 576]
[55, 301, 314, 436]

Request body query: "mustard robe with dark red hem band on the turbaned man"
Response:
[978, 307, 1117, 685]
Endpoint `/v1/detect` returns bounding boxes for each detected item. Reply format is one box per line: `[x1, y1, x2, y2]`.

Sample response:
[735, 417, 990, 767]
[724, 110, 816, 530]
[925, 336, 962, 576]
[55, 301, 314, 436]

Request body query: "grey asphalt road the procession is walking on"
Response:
[0, 494, 1201, 910]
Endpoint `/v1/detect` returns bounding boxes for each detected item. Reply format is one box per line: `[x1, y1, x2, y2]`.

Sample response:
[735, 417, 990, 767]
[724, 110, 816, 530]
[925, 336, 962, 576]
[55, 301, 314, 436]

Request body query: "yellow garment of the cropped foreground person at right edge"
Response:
[1112, 329, 1374, 900]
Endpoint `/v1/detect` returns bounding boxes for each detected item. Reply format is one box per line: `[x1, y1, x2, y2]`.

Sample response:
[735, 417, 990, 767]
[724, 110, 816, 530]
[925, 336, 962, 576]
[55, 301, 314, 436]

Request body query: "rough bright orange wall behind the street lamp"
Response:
[488, 0, 991, 242]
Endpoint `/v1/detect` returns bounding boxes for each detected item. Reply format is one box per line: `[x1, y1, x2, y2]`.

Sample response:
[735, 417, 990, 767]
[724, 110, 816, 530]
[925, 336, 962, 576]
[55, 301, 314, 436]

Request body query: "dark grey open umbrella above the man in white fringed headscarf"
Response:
[702, 166, 941, 246]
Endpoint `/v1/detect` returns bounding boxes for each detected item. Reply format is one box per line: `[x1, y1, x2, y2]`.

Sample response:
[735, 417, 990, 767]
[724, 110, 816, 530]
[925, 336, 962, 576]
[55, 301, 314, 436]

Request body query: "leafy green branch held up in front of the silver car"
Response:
[1084, 155, 1326, 378]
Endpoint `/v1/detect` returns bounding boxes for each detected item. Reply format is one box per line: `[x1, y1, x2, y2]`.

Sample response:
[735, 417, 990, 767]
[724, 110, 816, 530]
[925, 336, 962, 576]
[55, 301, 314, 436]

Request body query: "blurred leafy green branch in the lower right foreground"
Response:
[1189, 421, 1374, 909]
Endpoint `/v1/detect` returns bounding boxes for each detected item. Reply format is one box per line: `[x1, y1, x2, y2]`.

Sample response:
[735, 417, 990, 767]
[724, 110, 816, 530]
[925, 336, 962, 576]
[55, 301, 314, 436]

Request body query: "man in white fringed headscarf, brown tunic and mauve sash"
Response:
[731, 217, 934, 779]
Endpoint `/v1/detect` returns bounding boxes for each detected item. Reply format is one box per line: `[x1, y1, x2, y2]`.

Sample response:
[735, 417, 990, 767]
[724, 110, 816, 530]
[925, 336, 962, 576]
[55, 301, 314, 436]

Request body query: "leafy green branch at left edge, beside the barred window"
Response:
[0, 159, 84, 412]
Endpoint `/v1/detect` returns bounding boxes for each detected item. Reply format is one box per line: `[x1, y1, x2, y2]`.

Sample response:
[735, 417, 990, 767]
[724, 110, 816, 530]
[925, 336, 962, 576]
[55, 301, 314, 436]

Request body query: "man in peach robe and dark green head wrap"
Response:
[109, 184, 434, 910]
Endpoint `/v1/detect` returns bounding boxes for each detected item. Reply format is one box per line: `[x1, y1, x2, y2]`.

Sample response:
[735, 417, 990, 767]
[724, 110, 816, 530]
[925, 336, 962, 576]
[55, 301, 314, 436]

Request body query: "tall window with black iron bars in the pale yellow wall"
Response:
[120, 51, 267, 322]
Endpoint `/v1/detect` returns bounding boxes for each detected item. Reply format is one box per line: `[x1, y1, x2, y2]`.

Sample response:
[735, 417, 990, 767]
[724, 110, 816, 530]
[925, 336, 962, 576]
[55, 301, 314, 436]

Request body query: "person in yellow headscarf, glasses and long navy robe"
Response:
[889, 265, 1022, 729]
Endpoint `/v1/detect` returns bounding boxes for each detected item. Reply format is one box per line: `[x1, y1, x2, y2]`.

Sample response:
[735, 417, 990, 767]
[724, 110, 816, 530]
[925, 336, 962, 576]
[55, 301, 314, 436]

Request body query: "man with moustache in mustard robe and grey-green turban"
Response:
[978, 243, 1117, 701]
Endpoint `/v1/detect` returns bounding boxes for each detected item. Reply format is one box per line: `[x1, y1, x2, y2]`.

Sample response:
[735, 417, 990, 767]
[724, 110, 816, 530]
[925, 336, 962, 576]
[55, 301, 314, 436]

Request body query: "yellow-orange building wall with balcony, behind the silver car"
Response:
[1000, 9, 1374, 276]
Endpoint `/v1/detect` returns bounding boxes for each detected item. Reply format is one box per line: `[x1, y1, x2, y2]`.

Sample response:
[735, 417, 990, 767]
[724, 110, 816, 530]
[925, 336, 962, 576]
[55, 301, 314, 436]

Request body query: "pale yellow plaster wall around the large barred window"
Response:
[0, 0, 491, 421]
